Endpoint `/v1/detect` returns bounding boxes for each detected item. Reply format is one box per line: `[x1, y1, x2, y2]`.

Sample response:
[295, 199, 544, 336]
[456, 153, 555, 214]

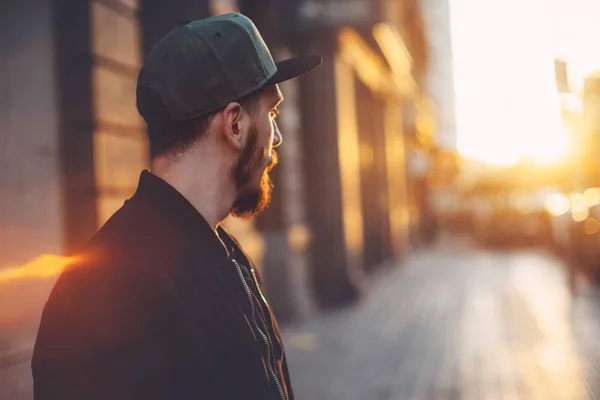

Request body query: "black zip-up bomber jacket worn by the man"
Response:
[32, 171, 293, 400]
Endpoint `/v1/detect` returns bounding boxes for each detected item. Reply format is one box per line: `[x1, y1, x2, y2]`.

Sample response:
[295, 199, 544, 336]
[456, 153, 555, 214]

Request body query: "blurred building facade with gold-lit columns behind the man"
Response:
[0, 0, 426, 400]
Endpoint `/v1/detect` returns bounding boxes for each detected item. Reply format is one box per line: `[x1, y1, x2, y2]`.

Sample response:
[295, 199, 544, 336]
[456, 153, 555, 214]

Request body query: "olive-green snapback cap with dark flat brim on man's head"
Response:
[137, 13, 321, 122]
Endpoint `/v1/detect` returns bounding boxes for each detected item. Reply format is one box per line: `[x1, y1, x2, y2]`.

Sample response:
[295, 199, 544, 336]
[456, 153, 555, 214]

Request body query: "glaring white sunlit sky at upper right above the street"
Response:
[450, 0, 600, 165]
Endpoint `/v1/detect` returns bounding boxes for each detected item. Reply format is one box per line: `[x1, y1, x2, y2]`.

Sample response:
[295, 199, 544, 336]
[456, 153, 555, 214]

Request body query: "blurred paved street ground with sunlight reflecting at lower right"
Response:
[284, 251, 600, 400]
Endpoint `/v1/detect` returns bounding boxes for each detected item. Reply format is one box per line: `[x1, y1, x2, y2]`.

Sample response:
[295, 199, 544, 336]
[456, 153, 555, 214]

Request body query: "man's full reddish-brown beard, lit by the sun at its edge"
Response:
[231, 127, 277, 219]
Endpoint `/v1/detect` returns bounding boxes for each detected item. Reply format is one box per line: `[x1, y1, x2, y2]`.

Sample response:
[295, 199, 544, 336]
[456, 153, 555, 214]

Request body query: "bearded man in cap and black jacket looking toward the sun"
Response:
[32, 14, 321, 400]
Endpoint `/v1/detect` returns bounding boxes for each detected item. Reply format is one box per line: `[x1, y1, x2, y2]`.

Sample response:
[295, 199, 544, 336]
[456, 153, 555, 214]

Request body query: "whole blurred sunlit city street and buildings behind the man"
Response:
[0, 0, 600, 400]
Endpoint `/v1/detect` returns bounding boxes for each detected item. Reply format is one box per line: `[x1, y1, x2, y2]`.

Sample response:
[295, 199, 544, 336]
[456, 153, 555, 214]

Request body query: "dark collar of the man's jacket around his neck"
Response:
[131, 170, 234, 258]
